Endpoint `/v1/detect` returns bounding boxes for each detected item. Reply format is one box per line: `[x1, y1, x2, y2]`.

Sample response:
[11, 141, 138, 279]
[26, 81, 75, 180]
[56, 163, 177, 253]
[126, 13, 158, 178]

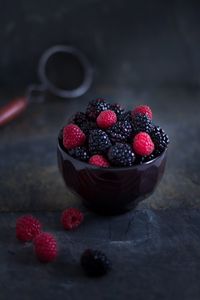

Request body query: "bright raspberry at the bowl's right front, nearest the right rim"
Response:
[133, 132, 155, 156]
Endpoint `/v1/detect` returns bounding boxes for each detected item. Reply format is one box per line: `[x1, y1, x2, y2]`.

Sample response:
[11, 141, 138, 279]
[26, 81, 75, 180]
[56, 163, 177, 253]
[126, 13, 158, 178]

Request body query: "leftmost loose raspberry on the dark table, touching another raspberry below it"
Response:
[16, 215, 42, 242]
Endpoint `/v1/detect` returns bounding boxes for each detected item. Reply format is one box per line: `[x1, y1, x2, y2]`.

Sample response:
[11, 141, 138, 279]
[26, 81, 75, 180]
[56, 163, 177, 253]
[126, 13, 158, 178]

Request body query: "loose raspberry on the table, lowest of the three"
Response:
[34, 232, 58, 262]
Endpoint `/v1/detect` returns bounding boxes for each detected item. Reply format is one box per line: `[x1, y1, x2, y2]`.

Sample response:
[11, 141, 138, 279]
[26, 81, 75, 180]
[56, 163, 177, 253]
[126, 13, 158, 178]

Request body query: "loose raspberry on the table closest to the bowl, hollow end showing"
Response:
[61, 208, 84, 230]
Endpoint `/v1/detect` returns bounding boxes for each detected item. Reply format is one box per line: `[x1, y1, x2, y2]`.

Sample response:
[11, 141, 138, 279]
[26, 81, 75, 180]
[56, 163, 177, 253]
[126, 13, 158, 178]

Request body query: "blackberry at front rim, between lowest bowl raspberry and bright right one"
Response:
[108, 143, 135, 167]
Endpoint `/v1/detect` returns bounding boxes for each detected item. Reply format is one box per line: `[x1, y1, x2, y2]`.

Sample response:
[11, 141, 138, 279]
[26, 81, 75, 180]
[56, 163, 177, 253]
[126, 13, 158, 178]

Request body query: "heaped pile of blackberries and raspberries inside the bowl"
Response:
[59, 98, 169, 167]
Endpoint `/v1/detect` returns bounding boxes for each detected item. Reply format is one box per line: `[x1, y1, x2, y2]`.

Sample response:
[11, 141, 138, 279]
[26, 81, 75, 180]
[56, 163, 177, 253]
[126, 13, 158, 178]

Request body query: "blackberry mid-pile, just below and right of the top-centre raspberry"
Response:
[106, 121, 133, 143]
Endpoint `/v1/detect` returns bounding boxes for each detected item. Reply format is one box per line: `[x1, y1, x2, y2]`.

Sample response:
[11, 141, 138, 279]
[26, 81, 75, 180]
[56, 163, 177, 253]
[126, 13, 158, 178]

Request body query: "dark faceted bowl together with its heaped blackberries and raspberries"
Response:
[57, 98, 169, 215]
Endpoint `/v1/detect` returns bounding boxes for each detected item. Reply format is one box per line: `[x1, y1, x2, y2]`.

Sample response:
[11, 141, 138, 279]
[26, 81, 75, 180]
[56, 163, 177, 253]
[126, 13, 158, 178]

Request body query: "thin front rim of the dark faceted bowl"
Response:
[57, 137, 168, 172]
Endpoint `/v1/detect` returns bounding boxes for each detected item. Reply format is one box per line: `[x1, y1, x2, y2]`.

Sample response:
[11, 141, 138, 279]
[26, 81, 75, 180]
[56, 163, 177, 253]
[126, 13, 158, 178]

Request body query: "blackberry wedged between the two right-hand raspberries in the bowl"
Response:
[132, 114, 153, 134]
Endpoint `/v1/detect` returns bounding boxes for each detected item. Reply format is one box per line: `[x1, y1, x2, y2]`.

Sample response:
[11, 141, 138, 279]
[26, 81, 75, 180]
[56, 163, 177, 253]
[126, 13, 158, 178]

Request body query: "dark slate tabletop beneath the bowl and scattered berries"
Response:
[0, 86, 200, 300]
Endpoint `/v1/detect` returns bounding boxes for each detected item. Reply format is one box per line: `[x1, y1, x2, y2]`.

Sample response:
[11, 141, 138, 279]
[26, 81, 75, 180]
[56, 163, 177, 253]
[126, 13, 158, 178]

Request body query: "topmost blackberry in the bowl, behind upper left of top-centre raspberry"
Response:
[86, 98, 110, 121]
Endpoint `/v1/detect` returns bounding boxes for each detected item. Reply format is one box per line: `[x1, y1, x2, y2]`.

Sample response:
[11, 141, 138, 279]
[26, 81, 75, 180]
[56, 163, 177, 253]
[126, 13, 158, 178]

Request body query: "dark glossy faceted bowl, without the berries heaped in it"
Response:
[57, 139, 167, 215]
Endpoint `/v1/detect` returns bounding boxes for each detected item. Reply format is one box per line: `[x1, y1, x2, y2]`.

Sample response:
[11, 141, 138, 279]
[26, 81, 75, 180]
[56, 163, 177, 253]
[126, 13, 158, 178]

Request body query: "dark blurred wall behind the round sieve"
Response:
[0, 0, 200, 89]
